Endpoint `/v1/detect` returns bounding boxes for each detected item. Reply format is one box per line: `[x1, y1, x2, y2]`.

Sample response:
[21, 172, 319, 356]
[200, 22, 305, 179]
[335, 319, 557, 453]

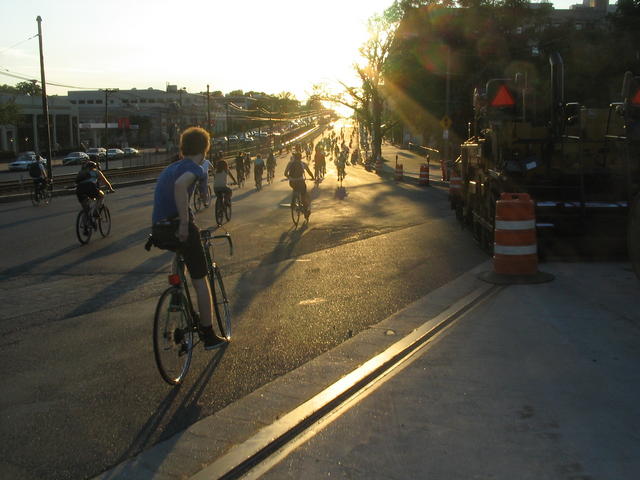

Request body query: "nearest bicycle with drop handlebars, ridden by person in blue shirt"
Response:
[145, 229, 233, 385]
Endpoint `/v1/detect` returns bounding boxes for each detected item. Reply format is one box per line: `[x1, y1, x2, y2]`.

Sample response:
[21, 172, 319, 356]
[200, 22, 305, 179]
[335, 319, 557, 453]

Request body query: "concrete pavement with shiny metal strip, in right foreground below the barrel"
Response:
[94, 263, 640, 479]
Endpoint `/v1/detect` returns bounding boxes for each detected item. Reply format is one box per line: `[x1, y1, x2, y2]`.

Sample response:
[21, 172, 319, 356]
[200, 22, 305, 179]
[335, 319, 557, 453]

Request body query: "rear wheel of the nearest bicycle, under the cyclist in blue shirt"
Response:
[153, 287, 193, 385]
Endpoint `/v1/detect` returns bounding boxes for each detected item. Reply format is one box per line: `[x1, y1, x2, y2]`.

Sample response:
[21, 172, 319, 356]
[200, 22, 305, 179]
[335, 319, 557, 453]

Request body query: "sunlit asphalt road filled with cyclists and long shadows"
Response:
[0, 121, 486, 479]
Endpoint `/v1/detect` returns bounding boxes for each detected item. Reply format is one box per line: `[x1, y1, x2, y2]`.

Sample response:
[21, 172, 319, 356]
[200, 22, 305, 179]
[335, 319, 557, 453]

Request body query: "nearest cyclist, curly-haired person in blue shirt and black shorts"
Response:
[152, 127, 226, 350]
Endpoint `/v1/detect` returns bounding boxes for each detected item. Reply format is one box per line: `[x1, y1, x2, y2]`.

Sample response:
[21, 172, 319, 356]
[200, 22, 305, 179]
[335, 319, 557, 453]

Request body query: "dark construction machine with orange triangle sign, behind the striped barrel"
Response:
[450, 54, 640, 278]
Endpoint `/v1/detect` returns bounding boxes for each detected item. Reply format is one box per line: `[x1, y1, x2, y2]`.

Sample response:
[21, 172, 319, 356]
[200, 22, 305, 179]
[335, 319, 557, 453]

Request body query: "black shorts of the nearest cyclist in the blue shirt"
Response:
[151, 221, 208, 280]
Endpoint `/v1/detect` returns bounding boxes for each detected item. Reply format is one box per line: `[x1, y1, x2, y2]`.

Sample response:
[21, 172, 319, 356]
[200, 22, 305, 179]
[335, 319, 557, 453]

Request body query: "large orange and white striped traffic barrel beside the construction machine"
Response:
[480, 193, 553, 284]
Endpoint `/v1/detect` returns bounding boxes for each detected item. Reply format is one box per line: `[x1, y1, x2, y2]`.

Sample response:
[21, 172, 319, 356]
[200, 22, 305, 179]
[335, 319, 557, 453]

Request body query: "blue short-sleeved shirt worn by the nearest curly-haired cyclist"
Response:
[151, 158, 207, 223]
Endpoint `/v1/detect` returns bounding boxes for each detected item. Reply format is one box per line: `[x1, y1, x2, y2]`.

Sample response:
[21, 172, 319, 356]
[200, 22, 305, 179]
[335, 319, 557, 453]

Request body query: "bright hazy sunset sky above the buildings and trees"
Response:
[0, 0, 600, 100]
